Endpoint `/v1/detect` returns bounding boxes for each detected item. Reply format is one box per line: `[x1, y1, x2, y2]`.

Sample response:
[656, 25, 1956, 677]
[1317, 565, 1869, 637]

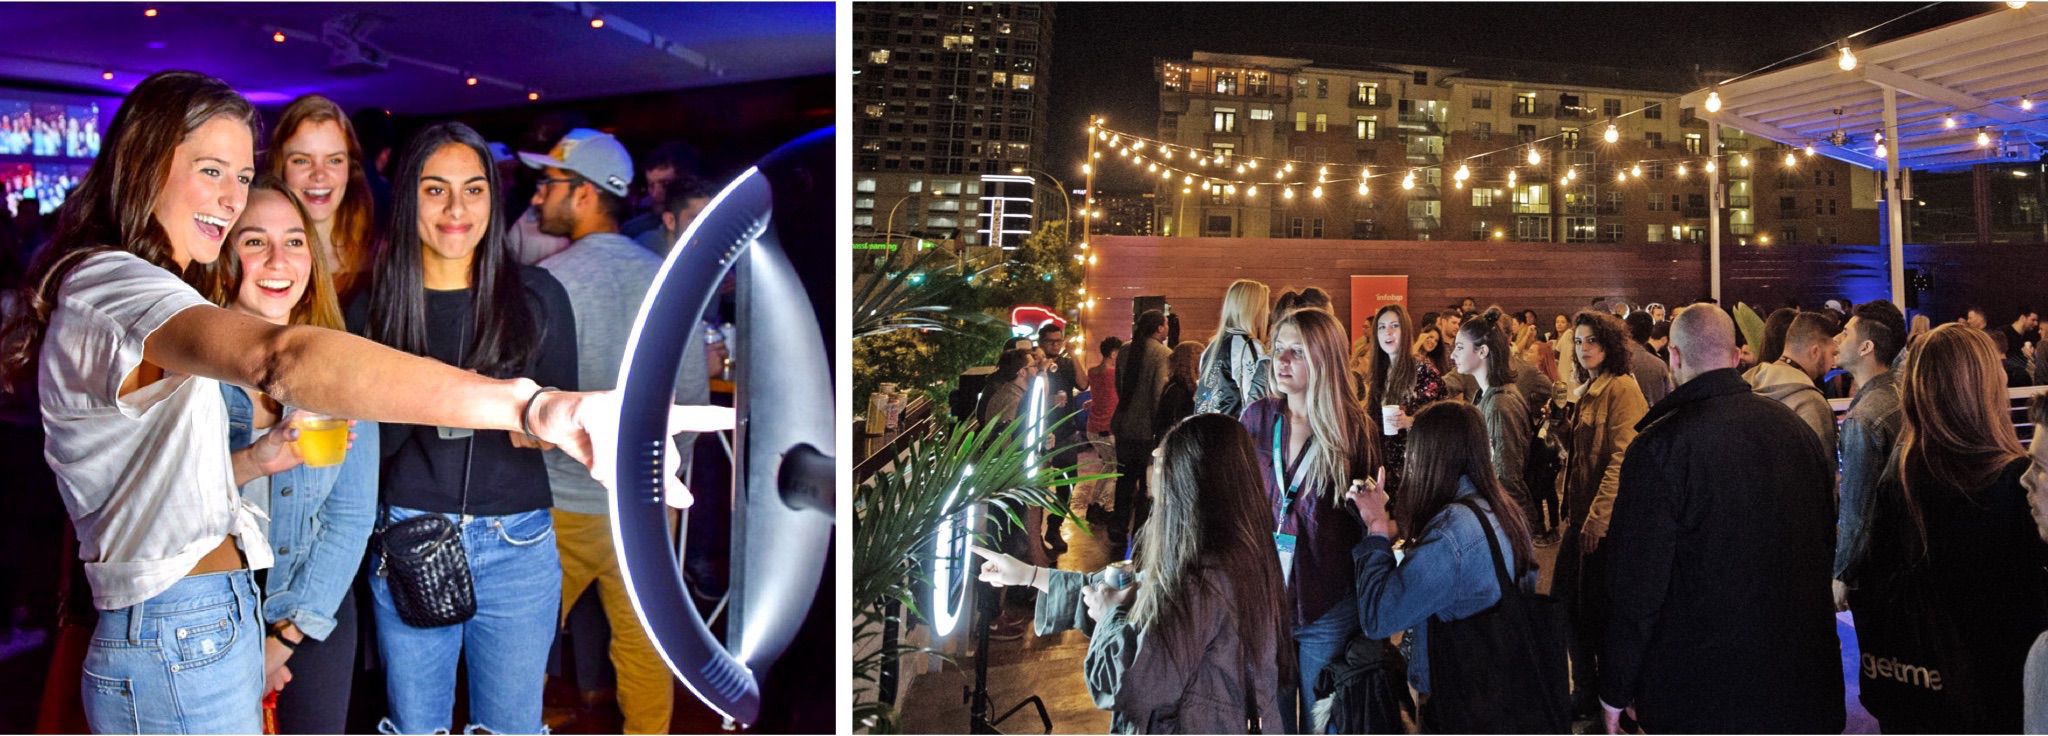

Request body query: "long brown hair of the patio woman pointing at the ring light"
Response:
[1130, 414, 1294, 688]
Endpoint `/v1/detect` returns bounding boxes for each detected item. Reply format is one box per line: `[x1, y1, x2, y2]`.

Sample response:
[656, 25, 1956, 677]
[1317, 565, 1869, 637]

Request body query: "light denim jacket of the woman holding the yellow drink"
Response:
[221, 383, 379, 640]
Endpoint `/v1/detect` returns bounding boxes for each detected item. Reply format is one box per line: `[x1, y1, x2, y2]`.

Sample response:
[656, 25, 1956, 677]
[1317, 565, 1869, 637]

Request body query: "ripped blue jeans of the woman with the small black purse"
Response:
[371, 506, 561, 734]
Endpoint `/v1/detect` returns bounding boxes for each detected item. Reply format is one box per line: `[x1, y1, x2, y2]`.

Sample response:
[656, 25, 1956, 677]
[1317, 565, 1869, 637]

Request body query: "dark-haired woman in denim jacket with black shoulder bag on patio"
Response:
[1346, 399, 1563, 734]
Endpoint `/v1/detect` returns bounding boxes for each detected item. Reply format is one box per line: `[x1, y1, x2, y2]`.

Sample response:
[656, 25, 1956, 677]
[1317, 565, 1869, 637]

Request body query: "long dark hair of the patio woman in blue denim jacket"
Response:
[1393, 402, 1536, 578]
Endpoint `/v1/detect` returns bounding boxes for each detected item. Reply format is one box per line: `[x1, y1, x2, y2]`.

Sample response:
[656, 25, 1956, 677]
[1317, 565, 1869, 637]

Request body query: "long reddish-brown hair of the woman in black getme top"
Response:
[1896, 322, 2028, 549]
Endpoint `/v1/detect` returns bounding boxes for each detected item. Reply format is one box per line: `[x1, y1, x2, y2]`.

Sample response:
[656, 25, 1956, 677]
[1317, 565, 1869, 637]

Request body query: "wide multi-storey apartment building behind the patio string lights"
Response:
[1143, 47, 1878, 246]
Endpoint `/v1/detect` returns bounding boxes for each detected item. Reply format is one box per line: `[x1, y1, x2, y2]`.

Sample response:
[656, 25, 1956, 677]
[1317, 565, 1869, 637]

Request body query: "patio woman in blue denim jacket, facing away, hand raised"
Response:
[1346, 402, 1536, 732]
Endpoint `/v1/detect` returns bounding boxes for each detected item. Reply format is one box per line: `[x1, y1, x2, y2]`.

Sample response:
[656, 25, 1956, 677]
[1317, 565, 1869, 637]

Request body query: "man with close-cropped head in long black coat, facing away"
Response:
[1599, 305, 1845, 734]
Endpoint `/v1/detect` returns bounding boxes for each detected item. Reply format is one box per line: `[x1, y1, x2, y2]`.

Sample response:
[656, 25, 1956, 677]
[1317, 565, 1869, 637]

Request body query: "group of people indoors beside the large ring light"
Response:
[0, 72, 733, 734]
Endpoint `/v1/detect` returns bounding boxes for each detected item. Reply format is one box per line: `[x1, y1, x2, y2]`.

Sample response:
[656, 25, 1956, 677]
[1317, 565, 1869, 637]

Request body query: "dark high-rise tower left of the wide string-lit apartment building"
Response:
[852, 2, 1057, 246]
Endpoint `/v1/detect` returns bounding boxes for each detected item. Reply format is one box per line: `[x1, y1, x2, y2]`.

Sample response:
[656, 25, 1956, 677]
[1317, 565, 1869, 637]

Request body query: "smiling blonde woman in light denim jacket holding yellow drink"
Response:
[209, 174, 379, 734]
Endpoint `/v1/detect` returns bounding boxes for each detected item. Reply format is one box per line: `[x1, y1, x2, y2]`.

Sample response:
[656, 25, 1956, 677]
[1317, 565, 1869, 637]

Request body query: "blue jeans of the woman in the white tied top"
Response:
[80, 570, 264, 734]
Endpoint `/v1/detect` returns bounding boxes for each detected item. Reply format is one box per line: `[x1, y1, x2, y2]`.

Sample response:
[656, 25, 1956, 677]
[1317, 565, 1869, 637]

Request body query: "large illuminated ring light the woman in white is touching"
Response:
[610, 127, 834, 726]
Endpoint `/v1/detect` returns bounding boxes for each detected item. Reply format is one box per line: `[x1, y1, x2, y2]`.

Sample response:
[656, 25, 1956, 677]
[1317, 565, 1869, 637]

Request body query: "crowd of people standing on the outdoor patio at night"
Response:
[977, 279, 2048, 734]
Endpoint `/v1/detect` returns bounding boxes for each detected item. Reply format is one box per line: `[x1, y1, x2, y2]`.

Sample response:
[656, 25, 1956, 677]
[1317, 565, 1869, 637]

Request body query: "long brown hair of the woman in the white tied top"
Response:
[0, 72, 262, 392]
